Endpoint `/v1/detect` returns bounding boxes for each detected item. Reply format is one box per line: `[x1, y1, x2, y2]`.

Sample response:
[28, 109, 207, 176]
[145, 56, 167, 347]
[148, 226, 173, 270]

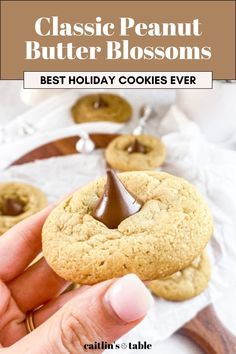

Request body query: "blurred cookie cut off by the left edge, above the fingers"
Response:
[0, 182, 47, 235]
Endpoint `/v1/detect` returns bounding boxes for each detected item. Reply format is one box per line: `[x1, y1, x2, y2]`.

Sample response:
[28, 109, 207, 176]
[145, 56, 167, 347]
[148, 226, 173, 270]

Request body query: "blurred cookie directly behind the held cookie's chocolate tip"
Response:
[105, 135, 166, 171]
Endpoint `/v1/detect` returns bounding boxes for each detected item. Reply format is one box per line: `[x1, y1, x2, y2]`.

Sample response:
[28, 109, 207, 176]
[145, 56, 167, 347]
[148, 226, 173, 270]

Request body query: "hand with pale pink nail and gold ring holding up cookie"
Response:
[0, 207, 152, 354]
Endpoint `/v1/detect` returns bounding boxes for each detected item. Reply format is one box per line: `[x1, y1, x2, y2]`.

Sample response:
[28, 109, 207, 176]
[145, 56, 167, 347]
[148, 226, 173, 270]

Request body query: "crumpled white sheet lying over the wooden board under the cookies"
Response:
[1, 106, 236, 348]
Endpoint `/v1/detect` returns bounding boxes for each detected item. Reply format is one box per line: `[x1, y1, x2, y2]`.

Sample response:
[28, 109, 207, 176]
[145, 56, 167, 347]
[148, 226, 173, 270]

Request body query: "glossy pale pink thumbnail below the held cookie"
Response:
[105, 274, 154, 323]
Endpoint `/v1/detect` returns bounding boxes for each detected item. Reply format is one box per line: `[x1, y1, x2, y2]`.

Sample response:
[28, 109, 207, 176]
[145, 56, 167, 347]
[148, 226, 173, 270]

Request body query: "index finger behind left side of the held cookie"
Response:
[0, 204, 55, 282]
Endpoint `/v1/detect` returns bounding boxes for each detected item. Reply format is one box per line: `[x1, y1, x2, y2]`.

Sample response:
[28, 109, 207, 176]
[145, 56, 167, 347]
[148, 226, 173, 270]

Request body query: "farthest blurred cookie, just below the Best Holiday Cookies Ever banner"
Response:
[71, 93, 132, 123]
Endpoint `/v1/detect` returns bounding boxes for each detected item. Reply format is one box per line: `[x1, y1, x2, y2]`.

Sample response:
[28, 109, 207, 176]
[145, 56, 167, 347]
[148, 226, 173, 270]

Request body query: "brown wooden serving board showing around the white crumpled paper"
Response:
[13, 134, 236, 354]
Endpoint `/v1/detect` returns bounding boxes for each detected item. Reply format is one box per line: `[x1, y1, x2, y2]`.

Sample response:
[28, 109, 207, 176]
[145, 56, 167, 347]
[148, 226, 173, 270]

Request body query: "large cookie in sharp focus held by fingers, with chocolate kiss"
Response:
[42, 170, 213, 284]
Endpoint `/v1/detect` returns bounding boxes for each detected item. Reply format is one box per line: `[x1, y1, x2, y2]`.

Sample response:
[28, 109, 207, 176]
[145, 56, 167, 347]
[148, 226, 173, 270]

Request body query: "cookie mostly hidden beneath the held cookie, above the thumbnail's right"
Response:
[148, 252, 211, 301]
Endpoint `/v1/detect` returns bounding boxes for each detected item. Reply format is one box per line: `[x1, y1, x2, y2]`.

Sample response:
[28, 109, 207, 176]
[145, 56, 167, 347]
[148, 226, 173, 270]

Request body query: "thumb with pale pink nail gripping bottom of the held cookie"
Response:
[11, 274, 153, 354]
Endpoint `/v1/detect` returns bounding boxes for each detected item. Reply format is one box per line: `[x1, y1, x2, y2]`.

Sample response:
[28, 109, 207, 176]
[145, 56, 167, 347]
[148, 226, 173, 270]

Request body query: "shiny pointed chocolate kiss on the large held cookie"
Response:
[91, 169, 142, 229]
